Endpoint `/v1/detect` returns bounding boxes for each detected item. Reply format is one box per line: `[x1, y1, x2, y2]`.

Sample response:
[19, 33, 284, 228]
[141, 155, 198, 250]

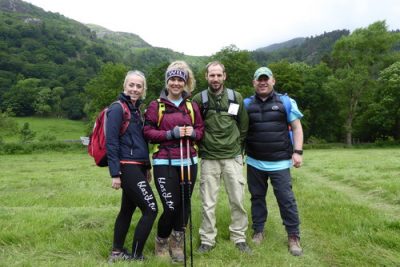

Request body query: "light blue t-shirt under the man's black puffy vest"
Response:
[246, 98, 303, 171]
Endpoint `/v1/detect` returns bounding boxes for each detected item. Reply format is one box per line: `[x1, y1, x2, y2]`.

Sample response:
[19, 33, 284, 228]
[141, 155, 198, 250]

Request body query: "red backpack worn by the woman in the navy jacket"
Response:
[88, 101, 131, 167]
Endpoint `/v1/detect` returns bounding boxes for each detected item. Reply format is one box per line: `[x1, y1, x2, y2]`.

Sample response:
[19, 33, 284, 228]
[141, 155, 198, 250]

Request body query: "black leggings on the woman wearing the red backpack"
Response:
[113, 164, 158, 257]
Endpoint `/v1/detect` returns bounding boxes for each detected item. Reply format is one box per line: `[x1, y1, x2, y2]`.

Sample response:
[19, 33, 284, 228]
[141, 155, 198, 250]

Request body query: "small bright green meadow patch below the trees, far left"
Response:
[4, 117, 87, 142]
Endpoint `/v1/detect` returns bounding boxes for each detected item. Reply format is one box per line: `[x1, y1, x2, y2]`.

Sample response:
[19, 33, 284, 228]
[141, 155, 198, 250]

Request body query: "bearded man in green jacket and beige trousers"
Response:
[193, 61, 251, 253]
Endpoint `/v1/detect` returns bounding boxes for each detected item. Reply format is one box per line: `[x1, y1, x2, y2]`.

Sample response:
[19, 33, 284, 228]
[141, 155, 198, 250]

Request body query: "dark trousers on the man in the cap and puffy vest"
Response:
[247, 165, 300, 236]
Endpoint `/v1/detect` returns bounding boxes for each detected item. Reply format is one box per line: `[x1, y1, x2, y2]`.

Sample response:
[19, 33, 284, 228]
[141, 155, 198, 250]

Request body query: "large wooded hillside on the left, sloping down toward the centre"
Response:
[0, 0, 204, 119]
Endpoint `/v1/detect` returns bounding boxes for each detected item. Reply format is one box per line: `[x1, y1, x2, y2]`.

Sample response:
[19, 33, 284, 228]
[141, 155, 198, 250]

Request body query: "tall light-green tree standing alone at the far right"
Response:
[329, 21, 396, 145]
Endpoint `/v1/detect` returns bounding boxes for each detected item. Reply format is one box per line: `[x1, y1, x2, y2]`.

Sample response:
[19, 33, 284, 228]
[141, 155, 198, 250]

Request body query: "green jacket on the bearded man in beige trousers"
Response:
[192, 88, 249, 159]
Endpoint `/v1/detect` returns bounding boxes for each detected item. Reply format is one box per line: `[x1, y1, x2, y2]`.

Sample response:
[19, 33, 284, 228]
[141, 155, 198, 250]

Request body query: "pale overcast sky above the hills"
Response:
[27, 0, 400, 56]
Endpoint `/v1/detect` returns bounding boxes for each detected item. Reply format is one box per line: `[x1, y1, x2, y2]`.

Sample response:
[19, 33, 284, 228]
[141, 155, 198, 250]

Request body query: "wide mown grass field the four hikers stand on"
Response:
[0, 148, 400, 267]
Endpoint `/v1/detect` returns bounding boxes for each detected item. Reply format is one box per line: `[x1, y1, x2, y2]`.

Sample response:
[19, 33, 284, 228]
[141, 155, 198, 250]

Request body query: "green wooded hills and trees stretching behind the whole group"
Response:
[0, 0, 400, 145]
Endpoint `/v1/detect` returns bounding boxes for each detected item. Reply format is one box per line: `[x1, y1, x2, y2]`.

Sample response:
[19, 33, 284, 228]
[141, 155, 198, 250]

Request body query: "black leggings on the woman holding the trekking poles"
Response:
[154, 164, 197, 238]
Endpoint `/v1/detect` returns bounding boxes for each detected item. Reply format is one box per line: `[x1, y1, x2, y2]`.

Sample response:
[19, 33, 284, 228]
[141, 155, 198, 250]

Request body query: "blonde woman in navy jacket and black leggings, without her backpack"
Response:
[106, 70, 158, 262]
